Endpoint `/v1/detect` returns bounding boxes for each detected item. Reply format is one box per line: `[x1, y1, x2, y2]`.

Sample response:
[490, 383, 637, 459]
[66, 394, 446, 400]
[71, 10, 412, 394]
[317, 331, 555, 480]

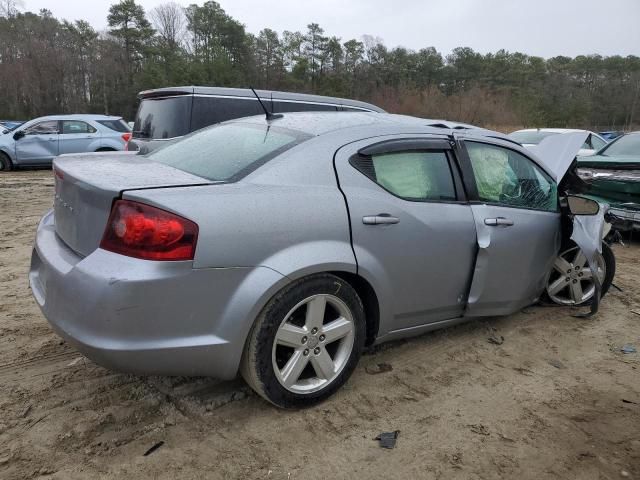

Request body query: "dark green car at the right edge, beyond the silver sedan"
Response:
[578, 132, 640, 230]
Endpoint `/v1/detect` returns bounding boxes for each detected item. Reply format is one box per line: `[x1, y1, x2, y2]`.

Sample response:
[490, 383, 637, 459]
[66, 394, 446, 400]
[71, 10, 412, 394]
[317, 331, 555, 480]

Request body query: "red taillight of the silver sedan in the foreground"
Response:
[100, 200, 198, 260]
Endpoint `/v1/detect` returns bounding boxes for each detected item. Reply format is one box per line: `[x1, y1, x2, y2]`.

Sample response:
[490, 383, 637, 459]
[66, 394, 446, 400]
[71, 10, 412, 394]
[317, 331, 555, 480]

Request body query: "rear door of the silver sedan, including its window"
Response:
[335, 136, 475, 335]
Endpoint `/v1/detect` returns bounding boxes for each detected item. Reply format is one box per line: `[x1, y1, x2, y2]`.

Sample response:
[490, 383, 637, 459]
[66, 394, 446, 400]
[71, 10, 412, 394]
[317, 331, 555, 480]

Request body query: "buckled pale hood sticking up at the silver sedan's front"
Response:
[529, 132, 589, 183]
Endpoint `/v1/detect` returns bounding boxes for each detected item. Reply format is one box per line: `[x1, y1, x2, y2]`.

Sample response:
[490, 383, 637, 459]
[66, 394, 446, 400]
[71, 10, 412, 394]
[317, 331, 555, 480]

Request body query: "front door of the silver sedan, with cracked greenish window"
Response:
[461, 139, 560, 316]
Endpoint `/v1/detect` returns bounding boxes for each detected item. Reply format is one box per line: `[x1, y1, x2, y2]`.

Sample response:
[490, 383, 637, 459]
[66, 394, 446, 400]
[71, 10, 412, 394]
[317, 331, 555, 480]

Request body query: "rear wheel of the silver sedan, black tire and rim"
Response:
[240, 274, 365, 408]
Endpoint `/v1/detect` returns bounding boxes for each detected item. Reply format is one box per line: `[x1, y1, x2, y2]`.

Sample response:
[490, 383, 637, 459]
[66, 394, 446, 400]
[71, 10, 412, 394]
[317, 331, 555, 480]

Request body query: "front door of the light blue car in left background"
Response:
[15, 120, 59, 165]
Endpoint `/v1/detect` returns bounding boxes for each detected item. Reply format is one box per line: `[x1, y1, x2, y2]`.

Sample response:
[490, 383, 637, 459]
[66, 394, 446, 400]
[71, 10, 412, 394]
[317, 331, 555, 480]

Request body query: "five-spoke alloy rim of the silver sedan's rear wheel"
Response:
[272, 294, 355, 394]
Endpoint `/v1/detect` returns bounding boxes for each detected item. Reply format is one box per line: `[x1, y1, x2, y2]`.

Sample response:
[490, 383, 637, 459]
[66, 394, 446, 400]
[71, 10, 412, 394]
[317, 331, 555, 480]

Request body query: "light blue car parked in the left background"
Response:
[0, 115, 131, 171]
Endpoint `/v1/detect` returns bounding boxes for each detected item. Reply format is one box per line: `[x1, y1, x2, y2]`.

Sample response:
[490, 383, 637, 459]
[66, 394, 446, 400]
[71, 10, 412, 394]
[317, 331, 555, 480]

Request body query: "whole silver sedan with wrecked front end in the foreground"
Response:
[29, 113, 615, 407]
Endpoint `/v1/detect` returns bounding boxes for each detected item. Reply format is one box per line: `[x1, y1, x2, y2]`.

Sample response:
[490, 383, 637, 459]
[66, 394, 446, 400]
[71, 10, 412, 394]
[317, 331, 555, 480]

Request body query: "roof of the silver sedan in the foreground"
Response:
[232, 112, 519, 145]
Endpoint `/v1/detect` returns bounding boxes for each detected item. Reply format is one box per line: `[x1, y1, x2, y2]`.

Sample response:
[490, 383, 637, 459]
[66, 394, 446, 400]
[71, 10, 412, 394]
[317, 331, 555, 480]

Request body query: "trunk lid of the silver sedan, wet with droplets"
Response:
[53, 153, 216, 256]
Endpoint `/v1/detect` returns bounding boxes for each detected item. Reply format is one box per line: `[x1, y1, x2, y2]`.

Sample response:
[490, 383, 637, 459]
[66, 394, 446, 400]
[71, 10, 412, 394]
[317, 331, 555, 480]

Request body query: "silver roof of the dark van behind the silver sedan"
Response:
[138, 85, 385, 113]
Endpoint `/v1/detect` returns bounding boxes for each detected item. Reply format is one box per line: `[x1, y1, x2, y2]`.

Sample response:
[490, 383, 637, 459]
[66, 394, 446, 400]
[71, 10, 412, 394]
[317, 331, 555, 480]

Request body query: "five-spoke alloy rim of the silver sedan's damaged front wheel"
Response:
[547, 247, 606, 305]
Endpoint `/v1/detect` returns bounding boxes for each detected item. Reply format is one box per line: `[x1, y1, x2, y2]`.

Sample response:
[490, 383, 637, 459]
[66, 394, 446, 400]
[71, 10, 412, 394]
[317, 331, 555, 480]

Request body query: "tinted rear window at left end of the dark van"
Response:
[133, 95, 193, 138]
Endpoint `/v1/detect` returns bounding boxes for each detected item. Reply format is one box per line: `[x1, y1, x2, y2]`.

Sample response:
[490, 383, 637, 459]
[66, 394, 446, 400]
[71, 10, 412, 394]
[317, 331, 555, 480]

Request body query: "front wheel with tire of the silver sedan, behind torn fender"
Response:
[546, 243, 616, 306]
